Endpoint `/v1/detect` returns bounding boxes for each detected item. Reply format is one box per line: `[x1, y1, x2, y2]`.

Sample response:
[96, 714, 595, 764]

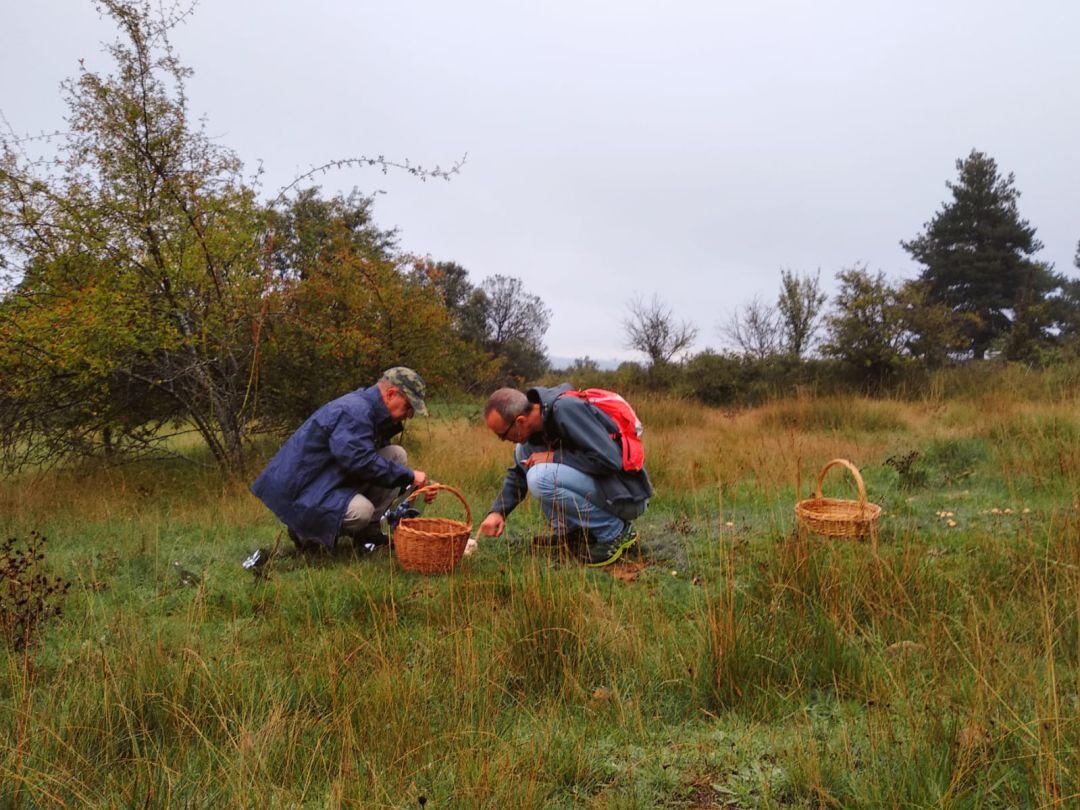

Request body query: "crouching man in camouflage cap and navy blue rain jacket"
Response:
[252, 366, 428, 549]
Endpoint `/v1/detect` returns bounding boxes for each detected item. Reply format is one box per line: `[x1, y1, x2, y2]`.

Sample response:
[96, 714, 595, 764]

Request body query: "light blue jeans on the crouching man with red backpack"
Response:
[514, 445, 625, 542]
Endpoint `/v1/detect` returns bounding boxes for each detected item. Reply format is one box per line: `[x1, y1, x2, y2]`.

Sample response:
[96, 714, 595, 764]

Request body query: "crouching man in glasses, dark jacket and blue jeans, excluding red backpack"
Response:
[480, 383, 652, 567]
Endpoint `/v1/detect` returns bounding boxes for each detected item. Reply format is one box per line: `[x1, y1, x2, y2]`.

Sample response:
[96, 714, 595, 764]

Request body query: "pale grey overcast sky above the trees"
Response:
[0, 0, 1080, 359]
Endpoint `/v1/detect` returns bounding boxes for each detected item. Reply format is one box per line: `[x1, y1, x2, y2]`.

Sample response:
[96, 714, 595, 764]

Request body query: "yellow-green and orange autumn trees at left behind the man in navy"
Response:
[0, 0, 485, 474]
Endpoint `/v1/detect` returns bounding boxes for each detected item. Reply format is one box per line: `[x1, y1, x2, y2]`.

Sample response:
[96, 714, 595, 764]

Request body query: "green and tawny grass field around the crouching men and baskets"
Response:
[0, 391, 1080, 808]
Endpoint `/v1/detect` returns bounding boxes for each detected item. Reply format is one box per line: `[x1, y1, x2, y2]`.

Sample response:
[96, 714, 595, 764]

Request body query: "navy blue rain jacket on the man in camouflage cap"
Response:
[252, 386, 413, 545]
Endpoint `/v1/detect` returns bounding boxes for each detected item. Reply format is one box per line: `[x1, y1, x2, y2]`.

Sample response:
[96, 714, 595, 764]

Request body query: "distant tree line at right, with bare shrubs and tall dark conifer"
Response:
[609, 150, 1080, 402]
